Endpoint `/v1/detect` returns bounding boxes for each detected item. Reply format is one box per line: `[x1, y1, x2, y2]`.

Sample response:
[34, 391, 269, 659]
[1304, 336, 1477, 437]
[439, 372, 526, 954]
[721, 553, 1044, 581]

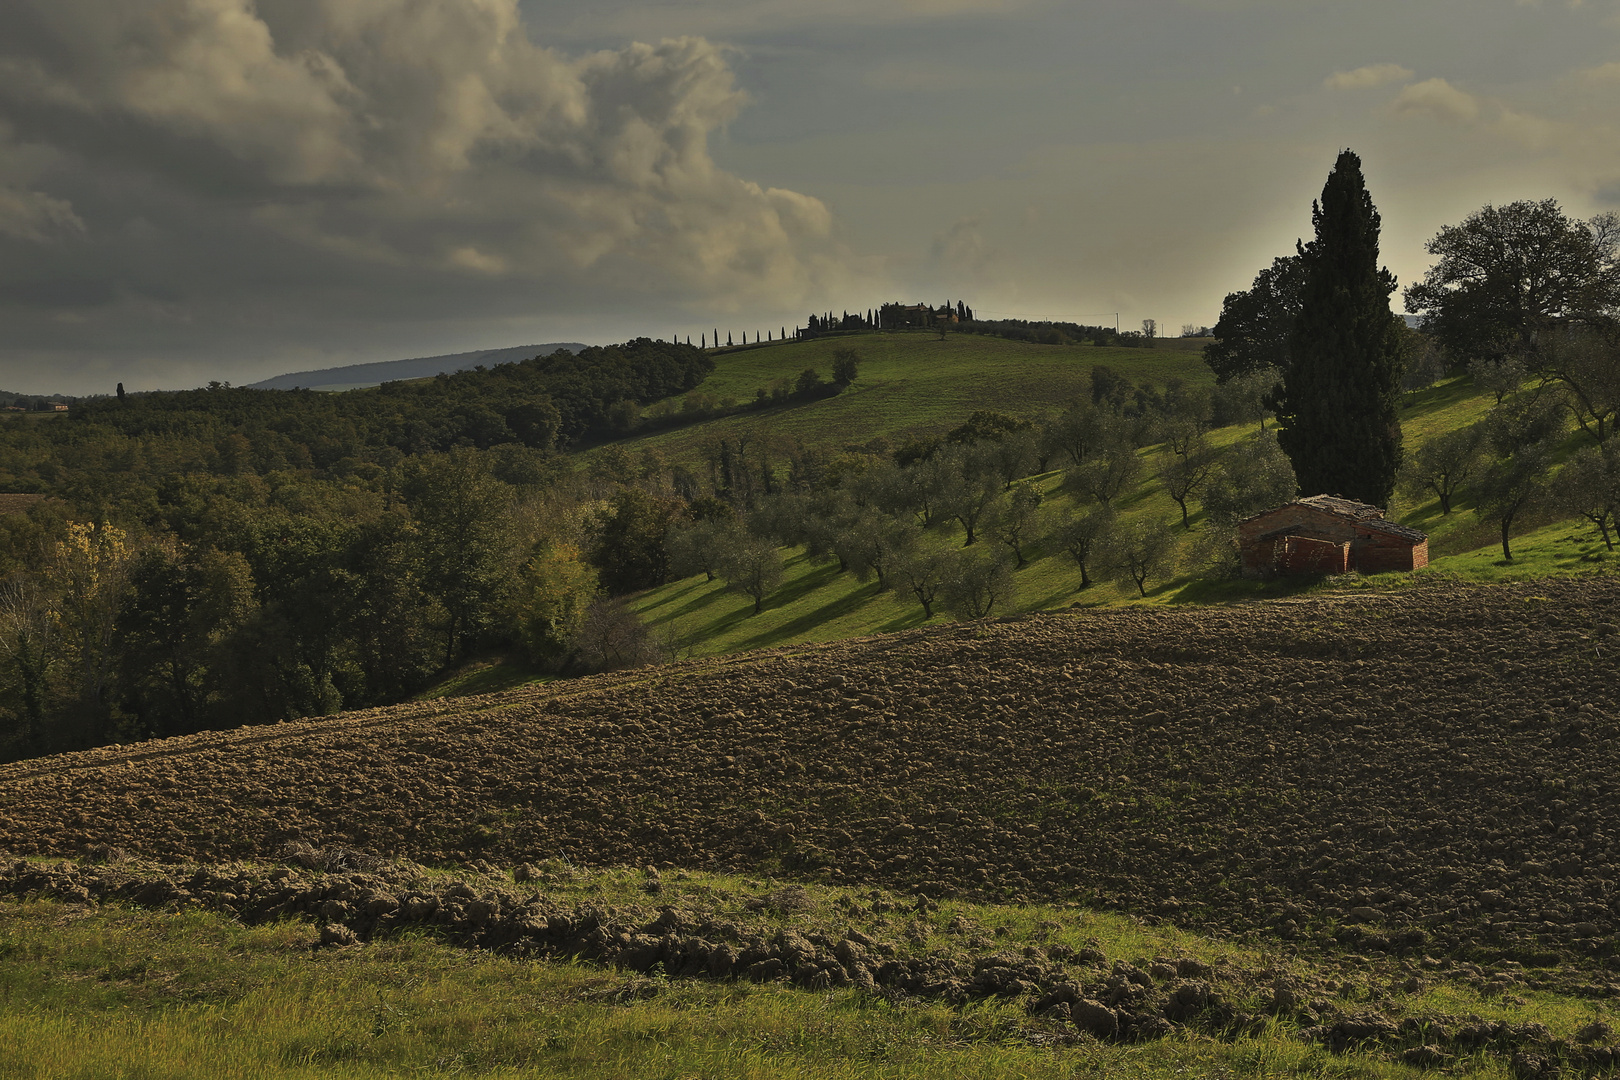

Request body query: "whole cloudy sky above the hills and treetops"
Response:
[0, 0, 1620, 393]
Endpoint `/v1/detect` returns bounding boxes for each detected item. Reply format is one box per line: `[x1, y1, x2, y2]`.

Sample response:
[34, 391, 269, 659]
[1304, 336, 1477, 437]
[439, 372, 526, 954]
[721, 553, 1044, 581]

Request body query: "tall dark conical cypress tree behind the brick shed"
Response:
[1270, 151, 1401, 507]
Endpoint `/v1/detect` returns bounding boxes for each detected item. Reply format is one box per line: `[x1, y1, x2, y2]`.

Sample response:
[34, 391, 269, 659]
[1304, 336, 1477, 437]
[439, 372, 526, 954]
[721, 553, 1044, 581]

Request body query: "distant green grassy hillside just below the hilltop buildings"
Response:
[632, 332, 1213, 460]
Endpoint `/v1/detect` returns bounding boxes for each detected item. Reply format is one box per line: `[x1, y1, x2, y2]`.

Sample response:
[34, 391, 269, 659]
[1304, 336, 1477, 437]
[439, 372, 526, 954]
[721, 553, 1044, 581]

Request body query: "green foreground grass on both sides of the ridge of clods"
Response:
[0, 871, 1614, 1080]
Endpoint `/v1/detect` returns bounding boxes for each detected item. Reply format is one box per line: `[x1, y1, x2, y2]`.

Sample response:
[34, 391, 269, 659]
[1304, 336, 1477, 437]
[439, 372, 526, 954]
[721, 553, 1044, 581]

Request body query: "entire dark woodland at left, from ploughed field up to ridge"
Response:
[0, 340, 710, 753]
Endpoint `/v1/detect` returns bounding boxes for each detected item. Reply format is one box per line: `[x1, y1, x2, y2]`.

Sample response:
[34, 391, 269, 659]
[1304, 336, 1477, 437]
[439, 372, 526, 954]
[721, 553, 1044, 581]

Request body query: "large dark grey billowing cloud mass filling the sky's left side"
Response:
[0, 0, 844, 387]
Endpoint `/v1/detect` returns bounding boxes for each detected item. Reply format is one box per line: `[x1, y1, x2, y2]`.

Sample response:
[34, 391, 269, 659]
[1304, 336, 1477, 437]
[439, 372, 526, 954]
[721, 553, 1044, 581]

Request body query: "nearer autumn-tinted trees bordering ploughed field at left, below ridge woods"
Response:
[0, 447, 631, 753]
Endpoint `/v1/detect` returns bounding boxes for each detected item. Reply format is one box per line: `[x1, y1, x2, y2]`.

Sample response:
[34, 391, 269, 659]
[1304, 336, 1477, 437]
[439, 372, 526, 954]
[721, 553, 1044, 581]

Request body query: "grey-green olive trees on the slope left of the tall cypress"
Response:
[648, 380, 1296, 619]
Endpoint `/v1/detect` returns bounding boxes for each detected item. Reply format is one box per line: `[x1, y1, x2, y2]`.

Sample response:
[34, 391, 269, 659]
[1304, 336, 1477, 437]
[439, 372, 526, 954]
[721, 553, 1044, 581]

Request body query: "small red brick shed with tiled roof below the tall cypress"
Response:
[1238, 495, 1429, 578]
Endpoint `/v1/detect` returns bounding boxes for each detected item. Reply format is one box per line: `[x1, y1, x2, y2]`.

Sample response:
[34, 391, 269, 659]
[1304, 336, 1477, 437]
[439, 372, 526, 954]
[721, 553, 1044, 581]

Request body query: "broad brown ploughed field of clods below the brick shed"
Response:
[0, 578, 1620, 960]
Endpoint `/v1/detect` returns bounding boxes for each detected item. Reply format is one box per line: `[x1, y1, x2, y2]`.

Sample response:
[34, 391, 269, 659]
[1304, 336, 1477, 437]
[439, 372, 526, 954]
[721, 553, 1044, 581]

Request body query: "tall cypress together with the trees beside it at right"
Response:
[1204, 151, 1620, 559]
